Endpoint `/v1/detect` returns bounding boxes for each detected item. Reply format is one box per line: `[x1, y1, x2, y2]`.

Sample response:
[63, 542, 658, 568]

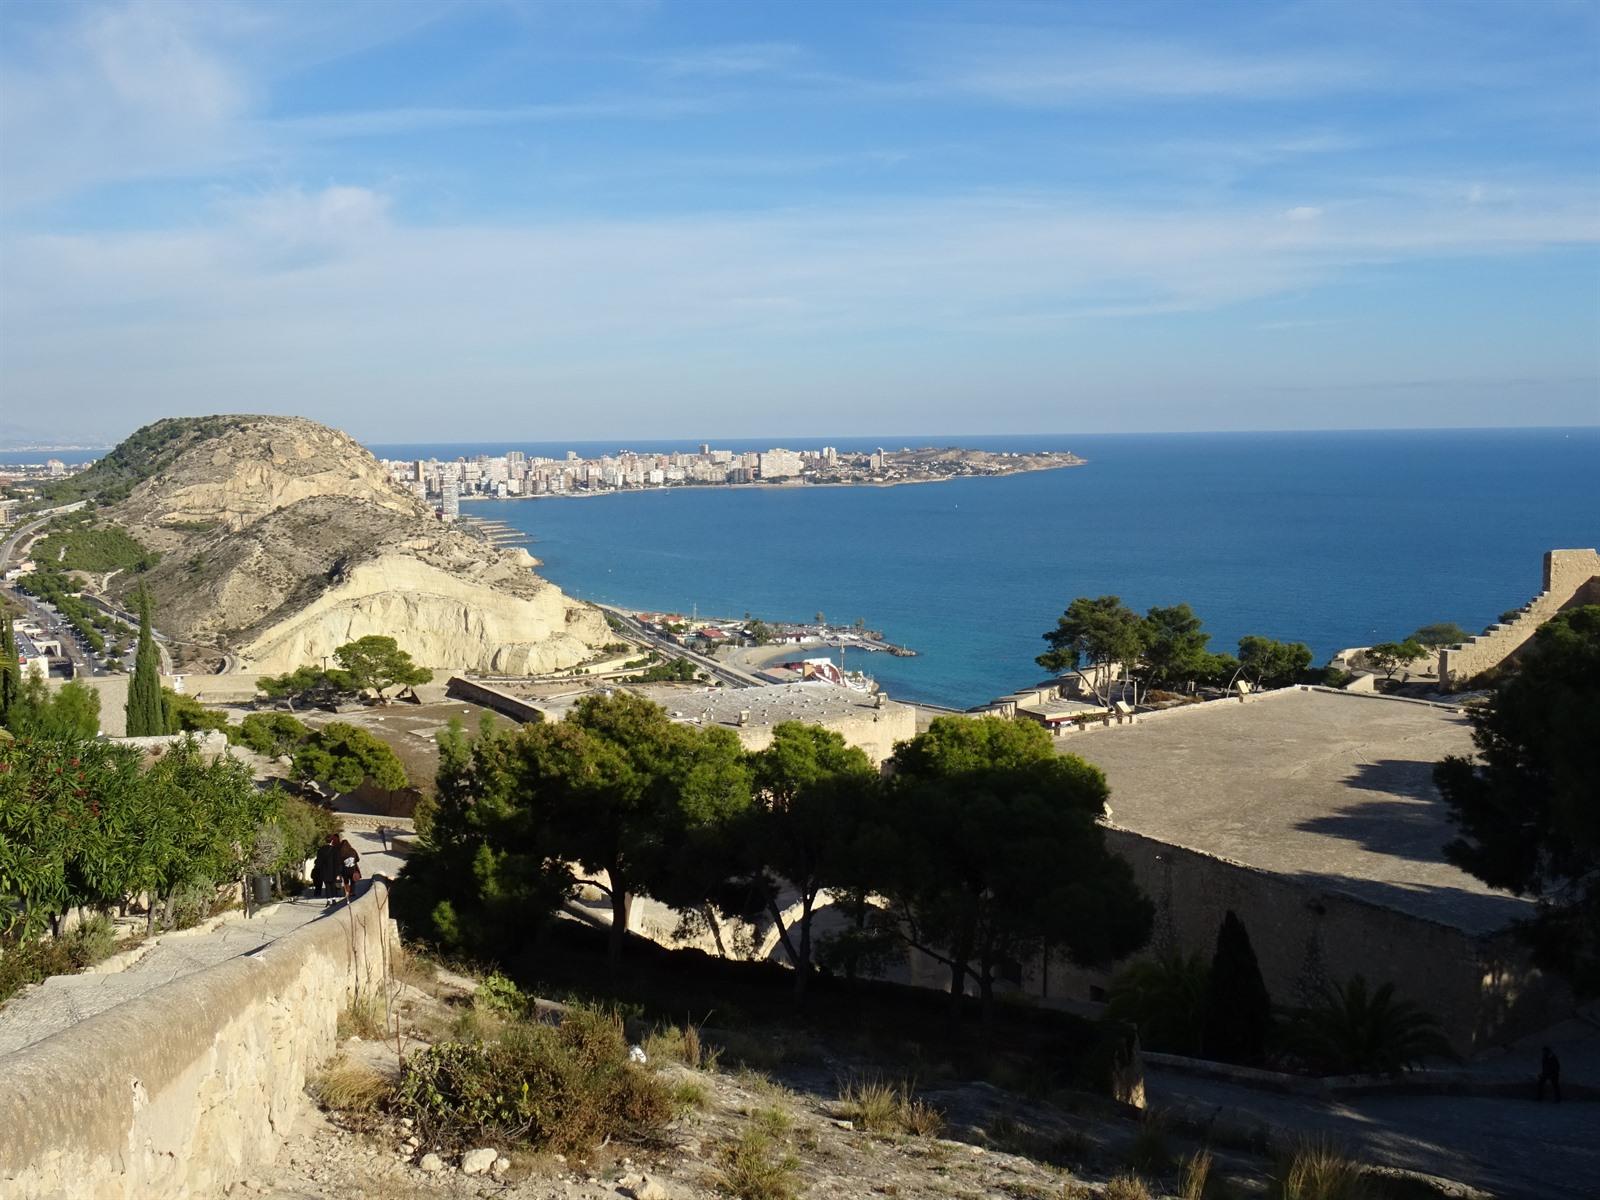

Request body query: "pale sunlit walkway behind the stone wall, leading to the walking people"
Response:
[0, 829, 402, 1056]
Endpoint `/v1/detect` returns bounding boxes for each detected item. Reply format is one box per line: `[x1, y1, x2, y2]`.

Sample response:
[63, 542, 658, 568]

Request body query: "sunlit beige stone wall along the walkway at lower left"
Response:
[0, 880, 392, 1200]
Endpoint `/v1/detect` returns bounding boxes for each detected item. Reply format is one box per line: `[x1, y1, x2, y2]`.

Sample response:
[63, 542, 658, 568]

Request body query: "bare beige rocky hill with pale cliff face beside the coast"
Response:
[89, 416, 610, 674]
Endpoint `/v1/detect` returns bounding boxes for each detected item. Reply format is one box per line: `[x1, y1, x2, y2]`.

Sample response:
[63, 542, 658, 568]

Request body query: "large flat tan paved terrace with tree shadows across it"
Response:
[1059, 688, 1528, 934]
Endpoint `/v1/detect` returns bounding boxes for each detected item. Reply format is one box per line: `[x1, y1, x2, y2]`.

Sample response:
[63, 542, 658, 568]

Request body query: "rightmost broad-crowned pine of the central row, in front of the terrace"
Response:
[882, 717, 1154, 1016]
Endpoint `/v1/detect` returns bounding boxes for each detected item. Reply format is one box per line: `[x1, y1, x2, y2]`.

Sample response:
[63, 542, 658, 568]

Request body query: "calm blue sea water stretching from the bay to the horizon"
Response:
[371, 427, 1600, 707]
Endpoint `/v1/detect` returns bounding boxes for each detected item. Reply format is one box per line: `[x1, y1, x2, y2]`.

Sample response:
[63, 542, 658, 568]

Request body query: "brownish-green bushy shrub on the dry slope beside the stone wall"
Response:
[395, 1010, 674, 1154]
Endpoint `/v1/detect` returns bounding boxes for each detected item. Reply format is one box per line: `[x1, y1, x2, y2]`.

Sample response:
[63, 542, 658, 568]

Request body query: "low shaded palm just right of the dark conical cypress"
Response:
[1283, 974, 1454, 1075]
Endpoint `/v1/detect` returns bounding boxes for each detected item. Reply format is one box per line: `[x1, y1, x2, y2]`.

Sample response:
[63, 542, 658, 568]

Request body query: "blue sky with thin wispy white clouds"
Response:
[0, 0, 1600, 442]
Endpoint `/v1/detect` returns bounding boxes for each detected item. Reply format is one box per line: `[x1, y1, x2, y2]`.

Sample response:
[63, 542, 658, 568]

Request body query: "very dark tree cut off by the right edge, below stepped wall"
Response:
[1434, 605, 1600, 995]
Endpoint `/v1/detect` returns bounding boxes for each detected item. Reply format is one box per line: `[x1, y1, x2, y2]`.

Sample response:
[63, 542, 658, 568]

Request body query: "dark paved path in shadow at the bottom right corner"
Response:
[1146, 1067, 1600, 1200]
